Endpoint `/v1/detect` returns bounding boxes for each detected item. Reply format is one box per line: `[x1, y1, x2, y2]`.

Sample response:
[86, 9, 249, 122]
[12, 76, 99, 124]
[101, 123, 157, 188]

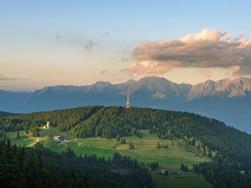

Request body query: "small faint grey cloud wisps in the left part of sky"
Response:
[56, 34, 97, 51]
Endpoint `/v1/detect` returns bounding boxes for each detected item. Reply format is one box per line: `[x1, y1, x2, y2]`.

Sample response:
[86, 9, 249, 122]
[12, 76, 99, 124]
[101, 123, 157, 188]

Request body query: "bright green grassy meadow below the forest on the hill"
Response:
[8, 128, 211, 188]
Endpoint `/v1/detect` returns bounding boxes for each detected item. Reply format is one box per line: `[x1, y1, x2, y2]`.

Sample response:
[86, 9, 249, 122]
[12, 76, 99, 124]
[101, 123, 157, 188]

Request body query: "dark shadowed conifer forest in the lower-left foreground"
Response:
[0, 140, 152, 188]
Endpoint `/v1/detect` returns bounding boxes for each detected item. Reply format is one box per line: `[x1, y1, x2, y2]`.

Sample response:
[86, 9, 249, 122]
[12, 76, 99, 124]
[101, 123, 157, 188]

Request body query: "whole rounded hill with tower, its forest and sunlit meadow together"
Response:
[0, 106, 251, 187]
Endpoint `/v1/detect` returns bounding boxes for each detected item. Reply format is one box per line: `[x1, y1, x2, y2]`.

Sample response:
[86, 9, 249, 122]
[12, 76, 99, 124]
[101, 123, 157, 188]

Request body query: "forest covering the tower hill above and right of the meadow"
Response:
[0, 107, 251, 187]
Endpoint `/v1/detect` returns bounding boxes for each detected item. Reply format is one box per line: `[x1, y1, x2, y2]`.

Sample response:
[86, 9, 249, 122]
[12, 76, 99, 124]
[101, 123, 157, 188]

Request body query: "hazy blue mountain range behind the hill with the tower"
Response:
[0, 77, 251, 132]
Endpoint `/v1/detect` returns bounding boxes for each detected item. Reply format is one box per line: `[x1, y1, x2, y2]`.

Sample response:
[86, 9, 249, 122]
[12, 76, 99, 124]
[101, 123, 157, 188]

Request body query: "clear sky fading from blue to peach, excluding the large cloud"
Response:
[0, 0, 251, 89]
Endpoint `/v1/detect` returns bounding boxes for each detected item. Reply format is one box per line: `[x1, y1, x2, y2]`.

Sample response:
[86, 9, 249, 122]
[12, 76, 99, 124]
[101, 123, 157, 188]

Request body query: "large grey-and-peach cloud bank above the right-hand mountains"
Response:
[126, 29, 251, 76]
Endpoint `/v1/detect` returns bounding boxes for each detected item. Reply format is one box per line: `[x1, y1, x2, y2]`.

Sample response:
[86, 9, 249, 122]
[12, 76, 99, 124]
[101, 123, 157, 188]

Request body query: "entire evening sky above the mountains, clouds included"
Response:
[0, 0, 251, 90]
